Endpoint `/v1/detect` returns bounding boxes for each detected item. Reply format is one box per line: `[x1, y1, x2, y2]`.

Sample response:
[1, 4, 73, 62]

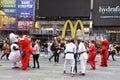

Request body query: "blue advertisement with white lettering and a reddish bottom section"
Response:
[17, 0, 34, 29]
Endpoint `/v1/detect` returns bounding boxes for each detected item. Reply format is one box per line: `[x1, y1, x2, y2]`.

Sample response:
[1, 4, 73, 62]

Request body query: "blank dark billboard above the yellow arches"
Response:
[37, 0, 91, 17]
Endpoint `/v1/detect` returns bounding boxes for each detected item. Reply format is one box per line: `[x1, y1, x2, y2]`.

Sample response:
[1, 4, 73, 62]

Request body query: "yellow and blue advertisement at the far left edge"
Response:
[0, 0, 17, 30]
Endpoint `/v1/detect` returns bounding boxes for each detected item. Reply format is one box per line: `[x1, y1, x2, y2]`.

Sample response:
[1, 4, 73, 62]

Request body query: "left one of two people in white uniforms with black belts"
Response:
[64, 39, 76, 77]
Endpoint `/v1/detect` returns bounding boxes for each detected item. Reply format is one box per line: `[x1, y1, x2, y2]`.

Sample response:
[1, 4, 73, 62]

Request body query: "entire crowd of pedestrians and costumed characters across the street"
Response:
[1, 33, 120, 77]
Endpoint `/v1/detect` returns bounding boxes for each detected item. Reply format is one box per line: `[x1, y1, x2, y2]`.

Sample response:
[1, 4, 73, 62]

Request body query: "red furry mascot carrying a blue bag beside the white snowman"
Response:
[19, 35, 33, 70]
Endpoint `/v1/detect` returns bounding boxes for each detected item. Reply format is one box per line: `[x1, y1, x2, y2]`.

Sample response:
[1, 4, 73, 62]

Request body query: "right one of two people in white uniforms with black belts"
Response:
[78, 40, 88, 75]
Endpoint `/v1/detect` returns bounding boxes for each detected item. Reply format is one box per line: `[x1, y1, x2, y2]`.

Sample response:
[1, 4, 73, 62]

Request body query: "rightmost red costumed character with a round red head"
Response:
[100, 39, 109, 67]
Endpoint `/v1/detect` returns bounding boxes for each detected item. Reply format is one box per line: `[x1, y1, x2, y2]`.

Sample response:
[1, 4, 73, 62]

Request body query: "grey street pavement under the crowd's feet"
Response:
[0, 53, 120, 80]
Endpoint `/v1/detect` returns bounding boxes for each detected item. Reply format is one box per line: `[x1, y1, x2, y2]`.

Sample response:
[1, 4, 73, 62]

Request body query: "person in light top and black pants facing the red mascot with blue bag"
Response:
[32, 40, 40, 68]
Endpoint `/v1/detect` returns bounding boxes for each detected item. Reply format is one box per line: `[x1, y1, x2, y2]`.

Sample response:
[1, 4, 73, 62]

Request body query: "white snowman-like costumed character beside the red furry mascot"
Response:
[9, 33, 21, 68]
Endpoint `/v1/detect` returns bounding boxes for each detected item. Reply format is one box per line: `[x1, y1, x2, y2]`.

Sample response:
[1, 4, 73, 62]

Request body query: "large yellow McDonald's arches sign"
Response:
[62, 20, 85, 38]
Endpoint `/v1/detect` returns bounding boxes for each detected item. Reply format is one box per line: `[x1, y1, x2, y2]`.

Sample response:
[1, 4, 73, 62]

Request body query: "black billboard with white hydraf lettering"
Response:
[93, 0, 120, 26]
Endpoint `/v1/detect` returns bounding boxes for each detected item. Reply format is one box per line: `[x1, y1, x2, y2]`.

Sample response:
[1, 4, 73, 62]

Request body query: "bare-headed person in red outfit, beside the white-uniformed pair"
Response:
[88, 40, 96, 70]
